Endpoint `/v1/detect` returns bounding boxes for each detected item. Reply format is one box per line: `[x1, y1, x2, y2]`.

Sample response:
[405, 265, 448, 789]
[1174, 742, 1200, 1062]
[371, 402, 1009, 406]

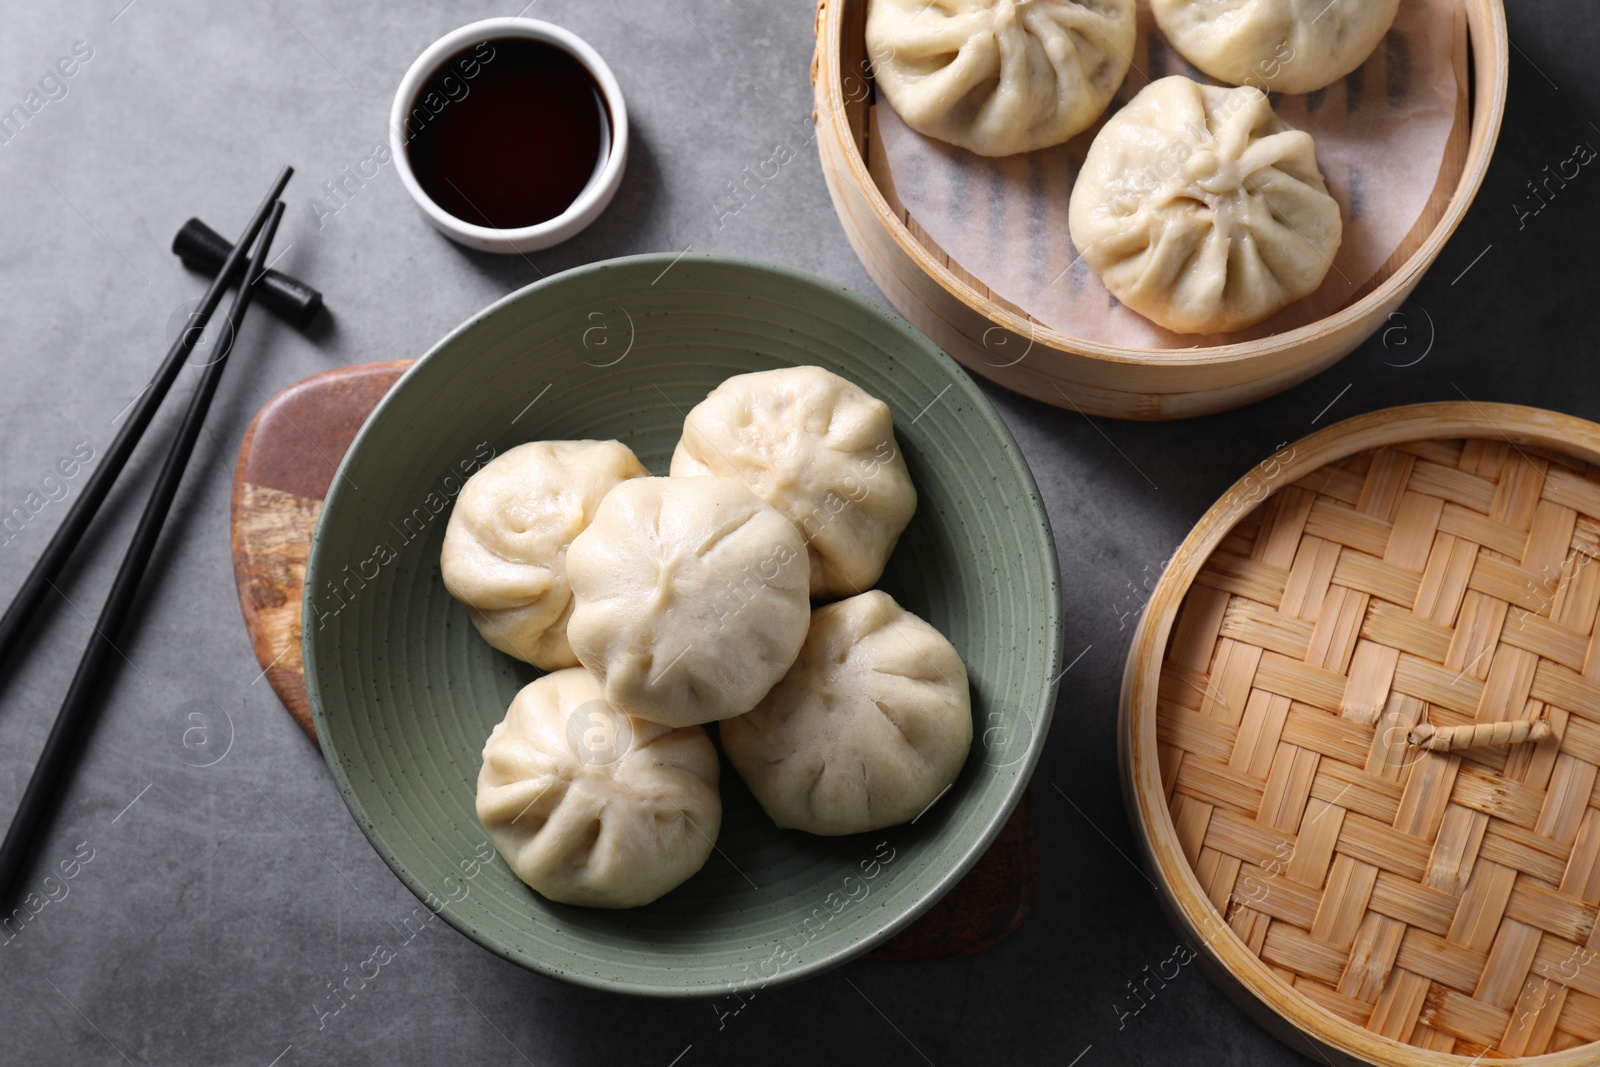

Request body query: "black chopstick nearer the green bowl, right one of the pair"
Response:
[0, 202, 283, 912]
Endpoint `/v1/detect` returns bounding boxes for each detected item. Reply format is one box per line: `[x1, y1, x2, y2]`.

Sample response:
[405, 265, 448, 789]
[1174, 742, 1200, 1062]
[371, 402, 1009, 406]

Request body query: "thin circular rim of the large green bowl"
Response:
[301, 253, 1066, 998]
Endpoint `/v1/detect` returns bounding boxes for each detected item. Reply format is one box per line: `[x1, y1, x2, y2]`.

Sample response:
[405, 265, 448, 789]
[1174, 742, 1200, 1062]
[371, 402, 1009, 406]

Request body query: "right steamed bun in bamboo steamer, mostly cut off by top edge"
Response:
[1150, 0, 1400, 93]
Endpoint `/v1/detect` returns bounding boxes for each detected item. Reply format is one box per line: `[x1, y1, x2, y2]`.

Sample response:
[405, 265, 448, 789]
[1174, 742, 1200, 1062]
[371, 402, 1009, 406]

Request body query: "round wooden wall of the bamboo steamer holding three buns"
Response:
[811, 0, 1509, 419]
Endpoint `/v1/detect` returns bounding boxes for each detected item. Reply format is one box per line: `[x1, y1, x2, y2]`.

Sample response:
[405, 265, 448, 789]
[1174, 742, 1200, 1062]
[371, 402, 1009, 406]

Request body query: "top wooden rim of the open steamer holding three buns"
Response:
[811, 0, 1510, 366]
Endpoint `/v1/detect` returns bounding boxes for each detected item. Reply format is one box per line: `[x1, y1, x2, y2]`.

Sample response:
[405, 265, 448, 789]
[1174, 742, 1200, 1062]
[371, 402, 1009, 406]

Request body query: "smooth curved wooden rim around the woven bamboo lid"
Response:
[1117, 400, 1600, 1067]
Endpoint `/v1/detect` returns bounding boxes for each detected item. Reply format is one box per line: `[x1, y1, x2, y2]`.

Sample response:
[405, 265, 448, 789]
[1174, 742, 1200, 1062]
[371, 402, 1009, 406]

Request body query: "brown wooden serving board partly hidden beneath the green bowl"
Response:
[232, 360, 1035, 961]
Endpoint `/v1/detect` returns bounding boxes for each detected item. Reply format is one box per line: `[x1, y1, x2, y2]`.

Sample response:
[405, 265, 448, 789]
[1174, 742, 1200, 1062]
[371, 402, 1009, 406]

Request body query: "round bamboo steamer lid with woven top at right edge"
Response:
[1118, 402, 1600, 1067]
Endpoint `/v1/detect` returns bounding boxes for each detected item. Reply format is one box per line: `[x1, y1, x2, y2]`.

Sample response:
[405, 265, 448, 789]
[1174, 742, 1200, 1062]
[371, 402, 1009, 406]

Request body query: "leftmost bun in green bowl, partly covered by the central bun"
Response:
[438, 442, 650, 670]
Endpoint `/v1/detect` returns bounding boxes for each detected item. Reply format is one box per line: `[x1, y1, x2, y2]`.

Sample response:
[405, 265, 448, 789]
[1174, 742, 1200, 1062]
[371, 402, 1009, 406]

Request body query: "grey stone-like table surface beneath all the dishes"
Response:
[0, 0, 1600, 1067]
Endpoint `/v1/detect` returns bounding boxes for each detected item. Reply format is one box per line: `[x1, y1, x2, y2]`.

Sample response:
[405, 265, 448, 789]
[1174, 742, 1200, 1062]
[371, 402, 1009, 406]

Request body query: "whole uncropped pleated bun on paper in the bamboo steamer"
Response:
[1067, 75, 1342, 333]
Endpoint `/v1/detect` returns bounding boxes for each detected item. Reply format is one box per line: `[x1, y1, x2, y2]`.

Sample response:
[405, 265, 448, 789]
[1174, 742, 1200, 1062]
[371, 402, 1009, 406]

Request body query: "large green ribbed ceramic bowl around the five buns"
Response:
[304, 256, 1061, 997]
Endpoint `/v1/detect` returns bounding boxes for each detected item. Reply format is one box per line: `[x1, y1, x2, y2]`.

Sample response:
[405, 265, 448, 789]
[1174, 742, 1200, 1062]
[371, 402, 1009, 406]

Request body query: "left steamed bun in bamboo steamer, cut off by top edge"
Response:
[867, 0, 1134, 155]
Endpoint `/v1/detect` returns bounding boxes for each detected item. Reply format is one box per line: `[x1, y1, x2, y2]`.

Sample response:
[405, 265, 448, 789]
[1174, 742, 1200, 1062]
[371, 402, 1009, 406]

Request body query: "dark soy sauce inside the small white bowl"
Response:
[405, 37, 611, 229]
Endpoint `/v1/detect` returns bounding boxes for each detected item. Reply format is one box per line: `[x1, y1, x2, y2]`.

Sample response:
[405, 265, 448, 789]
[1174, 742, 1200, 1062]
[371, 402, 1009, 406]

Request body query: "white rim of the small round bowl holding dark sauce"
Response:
[389, 16, 627, 254]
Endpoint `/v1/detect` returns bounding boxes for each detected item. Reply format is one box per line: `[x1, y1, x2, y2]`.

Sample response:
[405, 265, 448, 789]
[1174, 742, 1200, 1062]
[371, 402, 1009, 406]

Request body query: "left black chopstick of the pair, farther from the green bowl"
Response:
[0, 166, 294, 681]
